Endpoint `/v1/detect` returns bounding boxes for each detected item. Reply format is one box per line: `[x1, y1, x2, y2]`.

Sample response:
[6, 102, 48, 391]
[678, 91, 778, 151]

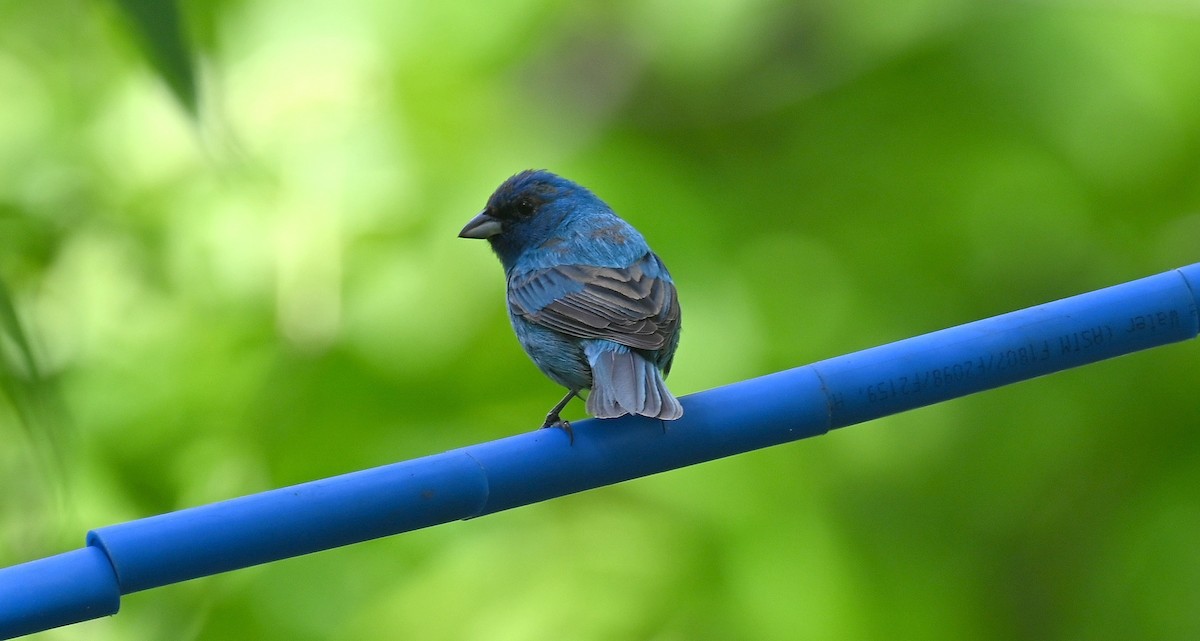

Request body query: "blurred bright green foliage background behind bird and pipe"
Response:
[0, 0, 1200, 641]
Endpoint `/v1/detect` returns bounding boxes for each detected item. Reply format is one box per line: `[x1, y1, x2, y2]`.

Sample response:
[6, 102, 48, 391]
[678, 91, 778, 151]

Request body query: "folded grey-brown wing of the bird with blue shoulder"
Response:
[509, 252, 679, 349]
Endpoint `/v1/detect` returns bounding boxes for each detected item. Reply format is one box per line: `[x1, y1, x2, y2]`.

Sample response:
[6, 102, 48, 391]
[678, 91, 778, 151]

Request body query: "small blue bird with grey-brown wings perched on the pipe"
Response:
[458, 169, 683, 441]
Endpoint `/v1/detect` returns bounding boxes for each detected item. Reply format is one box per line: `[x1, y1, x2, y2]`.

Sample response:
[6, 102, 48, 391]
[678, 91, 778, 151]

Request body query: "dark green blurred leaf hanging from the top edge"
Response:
[116, 0, 198, 116]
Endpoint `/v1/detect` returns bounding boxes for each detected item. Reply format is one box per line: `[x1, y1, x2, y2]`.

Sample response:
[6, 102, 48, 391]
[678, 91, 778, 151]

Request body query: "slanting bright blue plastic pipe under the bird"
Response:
[0, 263, 1200, 639]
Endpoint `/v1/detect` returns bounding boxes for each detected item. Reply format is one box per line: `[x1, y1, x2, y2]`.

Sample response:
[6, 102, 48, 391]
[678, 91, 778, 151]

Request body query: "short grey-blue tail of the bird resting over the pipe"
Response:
[584, 341, 683, 420]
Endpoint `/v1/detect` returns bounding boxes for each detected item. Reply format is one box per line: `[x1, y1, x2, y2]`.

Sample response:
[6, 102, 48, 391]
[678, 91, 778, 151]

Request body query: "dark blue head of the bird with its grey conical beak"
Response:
[458, 169, 585, 268]
